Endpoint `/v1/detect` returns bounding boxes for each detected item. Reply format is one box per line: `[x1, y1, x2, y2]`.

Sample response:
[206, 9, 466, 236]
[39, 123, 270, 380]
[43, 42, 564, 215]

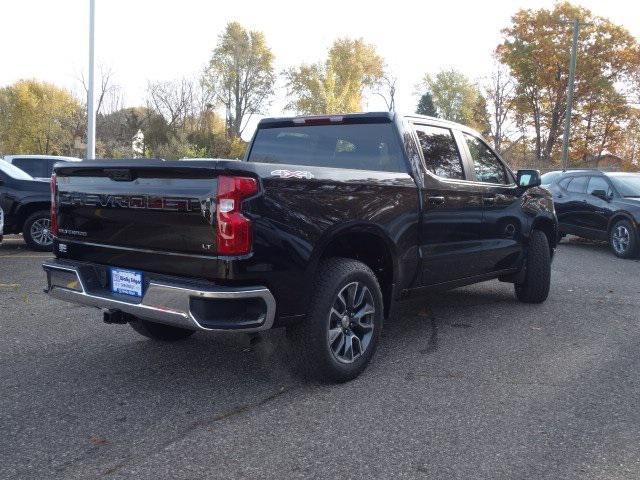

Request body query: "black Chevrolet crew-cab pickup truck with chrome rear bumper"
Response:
[44, 113, 557, 381]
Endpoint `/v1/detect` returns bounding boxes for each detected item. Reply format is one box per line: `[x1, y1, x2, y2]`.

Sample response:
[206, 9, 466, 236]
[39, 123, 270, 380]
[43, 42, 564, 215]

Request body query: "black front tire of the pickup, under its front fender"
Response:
[514, 230, 551, 303]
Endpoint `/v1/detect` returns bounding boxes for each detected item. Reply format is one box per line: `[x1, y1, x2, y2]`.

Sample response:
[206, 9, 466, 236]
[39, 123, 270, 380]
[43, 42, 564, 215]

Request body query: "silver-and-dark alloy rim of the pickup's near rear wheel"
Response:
[327, 282, 376, 363]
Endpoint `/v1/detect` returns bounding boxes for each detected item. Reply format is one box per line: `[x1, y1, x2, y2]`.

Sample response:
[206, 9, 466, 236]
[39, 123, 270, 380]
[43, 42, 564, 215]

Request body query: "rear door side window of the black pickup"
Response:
[415, 125, 464, 180]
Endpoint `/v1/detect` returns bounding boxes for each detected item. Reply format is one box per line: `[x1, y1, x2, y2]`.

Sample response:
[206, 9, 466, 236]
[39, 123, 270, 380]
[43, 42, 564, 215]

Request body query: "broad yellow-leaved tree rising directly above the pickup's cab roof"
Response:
[284, 38, 384, 114]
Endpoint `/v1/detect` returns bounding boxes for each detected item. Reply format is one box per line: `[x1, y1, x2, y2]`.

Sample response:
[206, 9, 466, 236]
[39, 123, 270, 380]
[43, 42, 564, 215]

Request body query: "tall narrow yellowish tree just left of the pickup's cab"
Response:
[204, 22, 275, 137]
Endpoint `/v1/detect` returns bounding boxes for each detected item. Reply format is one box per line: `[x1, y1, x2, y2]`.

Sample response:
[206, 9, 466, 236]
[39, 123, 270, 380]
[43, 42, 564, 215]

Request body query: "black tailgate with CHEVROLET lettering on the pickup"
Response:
[56, 160, 225, 255]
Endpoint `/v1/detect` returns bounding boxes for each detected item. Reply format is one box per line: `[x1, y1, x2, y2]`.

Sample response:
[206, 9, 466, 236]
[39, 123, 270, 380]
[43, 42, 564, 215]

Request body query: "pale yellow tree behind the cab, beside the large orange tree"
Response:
[422, 69, 490, 133]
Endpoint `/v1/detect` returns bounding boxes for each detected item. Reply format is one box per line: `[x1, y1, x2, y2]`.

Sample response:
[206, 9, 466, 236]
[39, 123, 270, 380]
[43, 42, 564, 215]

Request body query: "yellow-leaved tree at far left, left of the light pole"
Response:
[0, 80, 82, 155]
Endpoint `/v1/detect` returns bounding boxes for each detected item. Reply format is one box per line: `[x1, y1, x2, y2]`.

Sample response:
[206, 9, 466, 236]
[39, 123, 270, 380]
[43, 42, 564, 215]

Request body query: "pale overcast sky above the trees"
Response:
[0, 0, 640, 137]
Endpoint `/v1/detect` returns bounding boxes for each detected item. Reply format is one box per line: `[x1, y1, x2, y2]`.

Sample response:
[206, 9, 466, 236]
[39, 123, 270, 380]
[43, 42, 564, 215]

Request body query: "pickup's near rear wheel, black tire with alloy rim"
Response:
[287, 258, 384, 382]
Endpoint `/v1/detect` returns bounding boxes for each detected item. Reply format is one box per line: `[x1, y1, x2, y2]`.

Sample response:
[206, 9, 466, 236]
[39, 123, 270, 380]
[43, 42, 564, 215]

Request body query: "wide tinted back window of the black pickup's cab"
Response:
[248, 123, 407, 172]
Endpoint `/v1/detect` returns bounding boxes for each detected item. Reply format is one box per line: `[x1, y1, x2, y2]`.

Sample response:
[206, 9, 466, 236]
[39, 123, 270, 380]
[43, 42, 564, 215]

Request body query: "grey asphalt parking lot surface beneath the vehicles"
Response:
[0, 237, 640, 479]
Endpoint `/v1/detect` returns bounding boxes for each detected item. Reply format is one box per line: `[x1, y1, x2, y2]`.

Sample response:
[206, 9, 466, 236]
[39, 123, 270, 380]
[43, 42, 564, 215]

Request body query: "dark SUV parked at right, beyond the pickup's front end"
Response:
[548, 170, 640, 258]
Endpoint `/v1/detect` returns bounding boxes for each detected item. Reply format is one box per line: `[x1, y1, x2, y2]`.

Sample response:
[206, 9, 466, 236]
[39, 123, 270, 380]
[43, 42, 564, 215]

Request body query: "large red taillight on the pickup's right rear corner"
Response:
[216, 176, 258, 255]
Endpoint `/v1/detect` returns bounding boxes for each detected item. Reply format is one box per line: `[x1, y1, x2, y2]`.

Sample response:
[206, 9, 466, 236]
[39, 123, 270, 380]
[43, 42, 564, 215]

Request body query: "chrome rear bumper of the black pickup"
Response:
[42, 259, 276, 332]
